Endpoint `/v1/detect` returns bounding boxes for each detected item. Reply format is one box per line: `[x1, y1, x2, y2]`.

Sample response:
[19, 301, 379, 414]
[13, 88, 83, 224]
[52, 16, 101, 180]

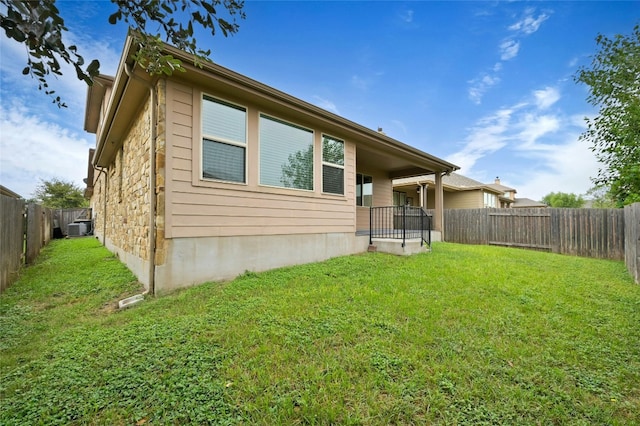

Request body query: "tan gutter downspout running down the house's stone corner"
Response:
[124, 63, 158, 295]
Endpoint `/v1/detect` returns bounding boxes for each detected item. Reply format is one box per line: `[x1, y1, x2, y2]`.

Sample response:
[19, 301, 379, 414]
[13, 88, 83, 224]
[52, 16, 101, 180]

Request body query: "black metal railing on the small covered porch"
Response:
[369, 206, 432, 247]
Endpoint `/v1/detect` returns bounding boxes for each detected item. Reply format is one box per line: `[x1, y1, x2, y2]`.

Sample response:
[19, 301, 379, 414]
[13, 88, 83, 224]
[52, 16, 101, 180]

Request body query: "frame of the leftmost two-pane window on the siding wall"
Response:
[199, 92, 249, 185]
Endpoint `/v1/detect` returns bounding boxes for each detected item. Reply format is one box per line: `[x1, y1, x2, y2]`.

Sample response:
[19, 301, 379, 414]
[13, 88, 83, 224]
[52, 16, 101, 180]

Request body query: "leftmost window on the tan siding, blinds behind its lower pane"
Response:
[202, 95, 247, 183]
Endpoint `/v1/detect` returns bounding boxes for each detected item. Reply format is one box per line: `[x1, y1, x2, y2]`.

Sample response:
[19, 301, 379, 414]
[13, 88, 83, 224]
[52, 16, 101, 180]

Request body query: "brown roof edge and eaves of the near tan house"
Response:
[85, 35, 459, 179]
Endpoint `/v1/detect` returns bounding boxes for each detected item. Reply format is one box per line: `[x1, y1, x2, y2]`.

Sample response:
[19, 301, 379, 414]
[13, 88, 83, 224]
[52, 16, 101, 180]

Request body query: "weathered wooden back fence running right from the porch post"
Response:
[444, 208, 625, 260]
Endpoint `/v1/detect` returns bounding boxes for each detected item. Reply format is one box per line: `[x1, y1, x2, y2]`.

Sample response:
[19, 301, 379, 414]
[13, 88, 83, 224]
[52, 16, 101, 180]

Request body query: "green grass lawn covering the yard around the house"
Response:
[0, 239, 640, 425]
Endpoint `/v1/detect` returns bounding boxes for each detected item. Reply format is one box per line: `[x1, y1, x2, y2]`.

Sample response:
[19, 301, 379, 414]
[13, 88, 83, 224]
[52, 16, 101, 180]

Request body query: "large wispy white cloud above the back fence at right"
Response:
[447, 83, 599, 200]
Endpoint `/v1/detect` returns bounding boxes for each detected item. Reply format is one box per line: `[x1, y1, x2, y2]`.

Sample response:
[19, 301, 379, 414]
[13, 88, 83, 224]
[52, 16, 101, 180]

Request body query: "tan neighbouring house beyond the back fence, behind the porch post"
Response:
[393, 173, 516, 209]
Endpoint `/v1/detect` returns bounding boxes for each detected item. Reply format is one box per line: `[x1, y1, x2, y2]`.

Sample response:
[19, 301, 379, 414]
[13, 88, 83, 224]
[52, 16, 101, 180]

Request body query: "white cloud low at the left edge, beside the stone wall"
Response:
[0, 104, 94, 198]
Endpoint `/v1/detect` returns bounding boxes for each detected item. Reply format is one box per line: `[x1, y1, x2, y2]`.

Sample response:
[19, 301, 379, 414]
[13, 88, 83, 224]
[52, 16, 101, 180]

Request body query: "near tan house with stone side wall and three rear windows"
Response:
[85, 37, 458, 294]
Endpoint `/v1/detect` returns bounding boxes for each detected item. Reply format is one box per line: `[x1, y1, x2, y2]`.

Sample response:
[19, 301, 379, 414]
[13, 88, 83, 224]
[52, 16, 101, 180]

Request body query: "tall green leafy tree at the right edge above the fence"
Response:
[574, 25, 640, 207]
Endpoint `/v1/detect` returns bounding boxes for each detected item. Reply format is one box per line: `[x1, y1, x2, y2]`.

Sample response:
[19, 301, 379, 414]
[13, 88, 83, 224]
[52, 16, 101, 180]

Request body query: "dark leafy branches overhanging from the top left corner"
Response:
[0, 0, 245, 107]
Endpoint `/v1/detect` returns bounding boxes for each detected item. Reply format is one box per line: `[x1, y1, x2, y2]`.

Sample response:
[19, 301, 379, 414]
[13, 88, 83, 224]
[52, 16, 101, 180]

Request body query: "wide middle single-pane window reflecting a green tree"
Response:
[260, 114, 313, 191]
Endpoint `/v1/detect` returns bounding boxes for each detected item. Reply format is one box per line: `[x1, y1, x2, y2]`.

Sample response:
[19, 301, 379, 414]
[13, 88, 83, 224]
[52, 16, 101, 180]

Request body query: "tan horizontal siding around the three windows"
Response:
[165, 81, 355, 238]
